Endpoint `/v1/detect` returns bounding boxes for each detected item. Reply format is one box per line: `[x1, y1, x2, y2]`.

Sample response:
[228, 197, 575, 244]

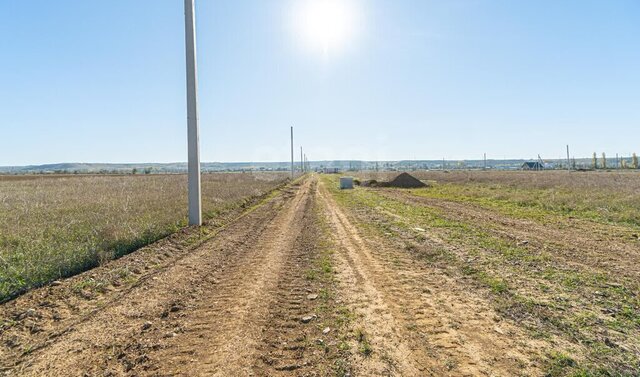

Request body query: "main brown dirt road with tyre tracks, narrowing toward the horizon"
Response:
[0, 176, 544, 376]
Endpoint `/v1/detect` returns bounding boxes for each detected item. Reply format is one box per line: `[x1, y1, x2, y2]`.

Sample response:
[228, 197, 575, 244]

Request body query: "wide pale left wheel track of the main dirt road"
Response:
[5, 182, 310, 376]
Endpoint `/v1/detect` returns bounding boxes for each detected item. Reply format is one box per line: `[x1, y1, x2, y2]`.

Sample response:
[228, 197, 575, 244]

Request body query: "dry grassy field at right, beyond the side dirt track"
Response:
[363, 171, 640, 226]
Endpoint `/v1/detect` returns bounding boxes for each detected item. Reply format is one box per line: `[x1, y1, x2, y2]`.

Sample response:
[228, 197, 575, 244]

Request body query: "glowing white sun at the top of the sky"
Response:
[294, 0, 359, 55]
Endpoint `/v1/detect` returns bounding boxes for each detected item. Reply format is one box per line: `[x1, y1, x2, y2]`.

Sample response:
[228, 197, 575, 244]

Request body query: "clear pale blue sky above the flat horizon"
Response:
[0, 0, 640, 165]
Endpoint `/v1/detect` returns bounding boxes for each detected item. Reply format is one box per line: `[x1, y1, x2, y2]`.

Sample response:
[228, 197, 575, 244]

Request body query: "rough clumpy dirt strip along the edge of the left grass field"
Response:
[0, 186, 284, 368]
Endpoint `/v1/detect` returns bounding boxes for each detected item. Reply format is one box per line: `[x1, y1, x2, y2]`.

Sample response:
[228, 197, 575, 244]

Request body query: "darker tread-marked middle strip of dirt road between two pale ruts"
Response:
[254, 181, 349, 377]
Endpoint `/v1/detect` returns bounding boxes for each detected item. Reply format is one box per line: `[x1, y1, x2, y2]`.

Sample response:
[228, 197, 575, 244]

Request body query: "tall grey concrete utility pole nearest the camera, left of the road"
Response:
[184, 0, 202, 225]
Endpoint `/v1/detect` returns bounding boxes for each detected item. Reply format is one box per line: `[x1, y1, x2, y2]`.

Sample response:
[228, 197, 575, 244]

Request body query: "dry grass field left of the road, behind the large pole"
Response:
[0, 173, 286, 301]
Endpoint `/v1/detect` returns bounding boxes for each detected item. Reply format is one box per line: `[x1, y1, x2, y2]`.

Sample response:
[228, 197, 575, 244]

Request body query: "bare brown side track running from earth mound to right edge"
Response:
[378, 190, 640, 281]
